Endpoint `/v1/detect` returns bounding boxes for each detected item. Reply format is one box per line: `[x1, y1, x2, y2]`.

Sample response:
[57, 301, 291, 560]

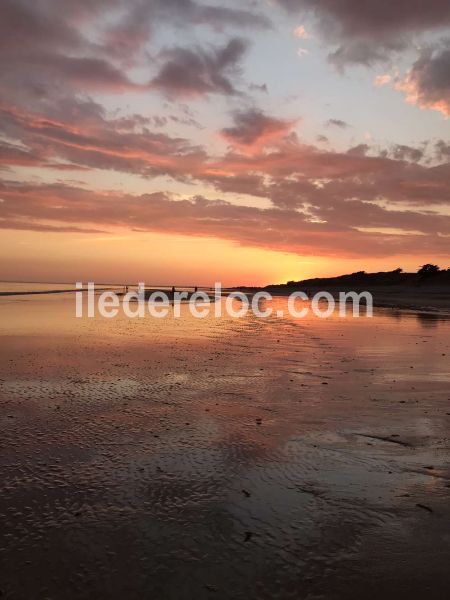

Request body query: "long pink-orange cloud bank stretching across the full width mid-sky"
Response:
[0, 101, 450, 220]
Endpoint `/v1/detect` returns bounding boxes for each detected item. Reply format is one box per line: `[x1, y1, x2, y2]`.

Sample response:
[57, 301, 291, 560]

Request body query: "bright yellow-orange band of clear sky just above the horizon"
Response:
[0, 231, 443, 286]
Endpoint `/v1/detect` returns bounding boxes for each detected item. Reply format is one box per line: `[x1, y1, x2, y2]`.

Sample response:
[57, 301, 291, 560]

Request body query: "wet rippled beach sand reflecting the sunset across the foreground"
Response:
[0, 295, 450, 600]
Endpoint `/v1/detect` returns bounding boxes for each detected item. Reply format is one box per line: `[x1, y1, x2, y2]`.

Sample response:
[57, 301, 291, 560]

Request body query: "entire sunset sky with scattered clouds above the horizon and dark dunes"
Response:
[0, 0, 450, 285]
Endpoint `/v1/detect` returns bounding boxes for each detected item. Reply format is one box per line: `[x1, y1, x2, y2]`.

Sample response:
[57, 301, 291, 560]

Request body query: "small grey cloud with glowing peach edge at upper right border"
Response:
[395, 40, 450, 117]
